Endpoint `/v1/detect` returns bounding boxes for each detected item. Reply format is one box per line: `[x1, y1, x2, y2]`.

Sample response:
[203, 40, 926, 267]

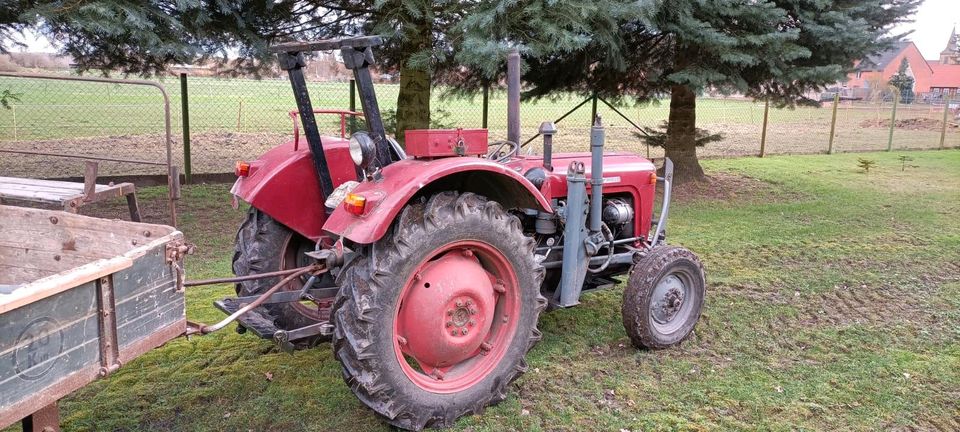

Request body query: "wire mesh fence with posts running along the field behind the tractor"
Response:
[0, 72, 960, 178]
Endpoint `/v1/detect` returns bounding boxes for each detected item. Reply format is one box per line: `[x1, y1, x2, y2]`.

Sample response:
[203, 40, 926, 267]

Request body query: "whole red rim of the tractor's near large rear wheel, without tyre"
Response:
[393, 240, 520, 393]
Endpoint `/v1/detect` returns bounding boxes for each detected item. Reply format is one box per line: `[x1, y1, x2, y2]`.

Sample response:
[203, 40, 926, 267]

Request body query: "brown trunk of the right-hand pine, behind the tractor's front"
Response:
[664, 85, 706, 183]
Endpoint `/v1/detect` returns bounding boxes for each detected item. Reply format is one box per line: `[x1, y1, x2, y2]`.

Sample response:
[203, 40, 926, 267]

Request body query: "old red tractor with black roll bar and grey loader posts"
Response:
[217, 37, 705, 430]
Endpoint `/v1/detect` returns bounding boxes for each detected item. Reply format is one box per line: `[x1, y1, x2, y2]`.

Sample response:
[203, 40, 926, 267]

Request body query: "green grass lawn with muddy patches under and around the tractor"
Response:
[9, 150, 960, 431]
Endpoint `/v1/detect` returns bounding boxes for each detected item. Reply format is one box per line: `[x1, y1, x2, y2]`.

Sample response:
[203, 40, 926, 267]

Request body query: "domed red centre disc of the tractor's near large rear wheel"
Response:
[397, 249, 497, 373]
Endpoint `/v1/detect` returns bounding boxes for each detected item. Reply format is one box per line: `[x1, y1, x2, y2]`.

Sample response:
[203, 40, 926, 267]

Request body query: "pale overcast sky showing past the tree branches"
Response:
[9, 0, 960, 59]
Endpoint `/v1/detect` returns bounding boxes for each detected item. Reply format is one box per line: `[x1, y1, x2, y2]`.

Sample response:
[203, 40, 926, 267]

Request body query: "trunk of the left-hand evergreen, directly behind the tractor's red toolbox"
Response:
[396, 15, 433, 144]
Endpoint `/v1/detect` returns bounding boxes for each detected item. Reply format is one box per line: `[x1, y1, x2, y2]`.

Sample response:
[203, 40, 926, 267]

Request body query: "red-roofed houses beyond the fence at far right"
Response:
[845, 28, 960, 96]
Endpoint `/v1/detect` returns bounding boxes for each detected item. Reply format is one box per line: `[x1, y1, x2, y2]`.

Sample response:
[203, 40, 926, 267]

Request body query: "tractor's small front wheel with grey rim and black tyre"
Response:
[623, 246, 706, 349]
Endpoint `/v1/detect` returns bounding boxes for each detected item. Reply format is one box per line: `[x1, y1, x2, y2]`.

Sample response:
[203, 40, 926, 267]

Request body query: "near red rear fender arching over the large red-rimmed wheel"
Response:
[323, 157, 552, 244]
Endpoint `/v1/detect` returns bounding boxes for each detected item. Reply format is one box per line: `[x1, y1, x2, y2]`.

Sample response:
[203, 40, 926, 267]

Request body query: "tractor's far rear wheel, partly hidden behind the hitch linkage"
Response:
[233, 207, 333, 348]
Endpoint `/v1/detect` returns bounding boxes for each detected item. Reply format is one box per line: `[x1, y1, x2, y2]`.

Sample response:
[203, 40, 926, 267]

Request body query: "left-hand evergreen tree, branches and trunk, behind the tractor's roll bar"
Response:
[0, 0, 470, 138]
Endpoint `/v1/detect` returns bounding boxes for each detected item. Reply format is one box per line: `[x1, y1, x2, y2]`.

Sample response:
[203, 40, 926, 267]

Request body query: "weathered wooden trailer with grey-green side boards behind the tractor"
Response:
[0, 205, 187, 431]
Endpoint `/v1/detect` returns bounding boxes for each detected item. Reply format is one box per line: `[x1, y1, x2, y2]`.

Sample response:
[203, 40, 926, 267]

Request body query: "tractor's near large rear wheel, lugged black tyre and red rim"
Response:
[333, 192, 546, 430]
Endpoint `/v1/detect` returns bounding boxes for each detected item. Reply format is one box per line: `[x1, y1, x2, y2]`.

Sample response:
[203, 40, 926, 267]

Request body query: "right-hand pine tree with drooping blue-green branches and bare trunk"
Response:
[459, 0, 919, 182]
